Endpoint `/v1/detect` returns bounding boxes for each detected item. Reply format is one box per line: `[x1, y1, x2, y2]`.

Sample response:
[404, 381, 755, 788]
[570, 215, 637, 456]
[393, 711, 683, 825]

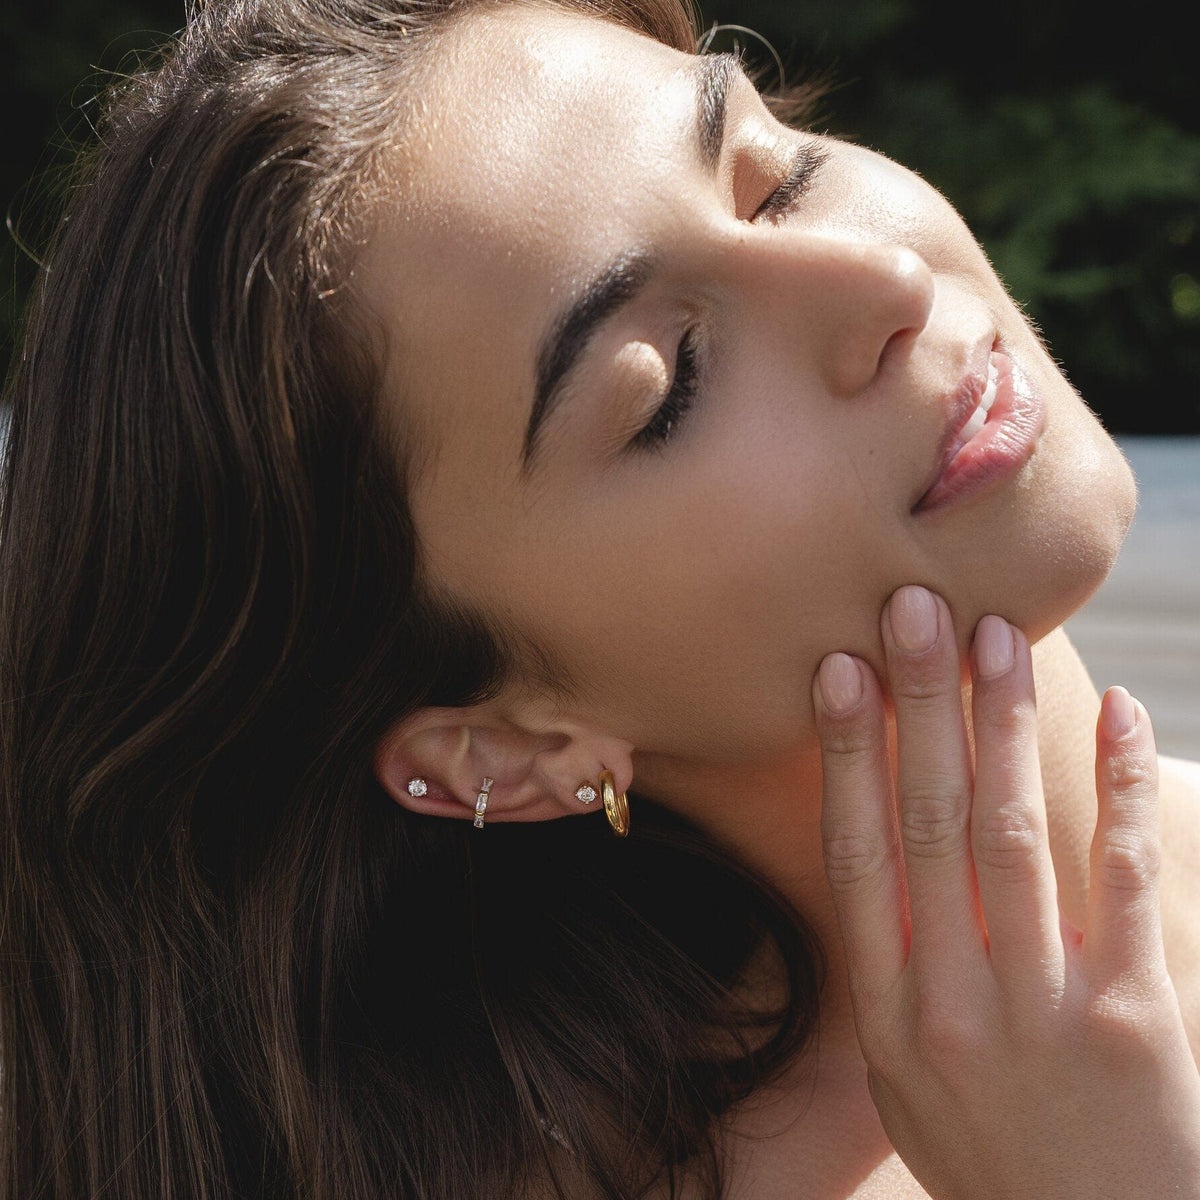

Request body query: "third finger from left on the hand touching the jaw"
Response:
[971, 617, 1063, 1001]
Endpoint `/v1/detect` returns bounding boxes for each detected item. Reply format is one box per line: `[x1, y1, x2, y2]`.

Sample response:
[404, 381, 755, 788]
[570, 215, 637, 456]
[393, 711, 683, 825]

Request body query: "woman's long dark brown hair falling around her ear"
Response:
[0, 0, 818, 1200]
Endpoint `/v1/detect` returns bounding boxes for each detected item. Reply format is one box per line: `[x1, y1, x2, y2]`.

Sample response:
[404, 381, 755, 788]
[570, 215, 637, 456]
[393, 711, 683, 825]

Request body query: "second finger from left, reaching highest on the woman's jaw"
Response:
[883, 587, 984, 976]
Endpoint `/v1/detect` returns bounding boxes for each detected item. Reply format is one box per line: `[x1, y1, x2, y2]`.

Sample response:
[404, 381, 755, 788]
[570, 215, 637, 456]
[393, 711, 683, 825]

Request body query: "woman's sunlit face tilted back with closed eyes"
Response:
[360, 6, 1133, 762]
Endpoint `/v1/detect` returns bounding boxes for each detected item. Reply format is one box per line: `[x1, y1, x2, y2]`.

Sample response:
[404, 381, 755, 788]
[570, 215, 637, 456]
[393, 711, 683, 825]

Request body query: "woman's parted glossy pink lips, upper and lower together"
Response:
[912, 338, 1045, 514]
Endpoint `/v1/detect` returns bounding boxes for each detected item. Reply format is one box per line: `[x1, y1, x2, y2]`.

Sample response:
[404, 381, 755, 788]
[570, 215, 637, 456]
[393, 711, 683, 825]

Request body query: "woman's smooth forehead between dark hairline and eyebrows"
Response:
[359, 6, 695, 462]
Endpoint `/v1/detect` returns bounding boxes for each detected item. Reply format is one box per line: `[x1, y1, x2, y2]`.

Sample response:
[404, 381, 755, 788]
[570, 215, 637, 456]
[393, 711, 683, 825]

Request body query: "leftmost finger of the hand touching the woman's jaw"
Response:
[814, 654, 907, 995]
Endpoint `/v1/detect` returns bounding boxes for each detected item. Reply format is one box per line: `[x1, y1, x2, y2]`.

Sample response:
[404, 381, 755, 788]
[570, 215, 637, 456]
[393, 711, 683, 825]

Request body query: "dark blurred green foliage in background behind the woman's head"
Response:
[0, 0, 1200, 432]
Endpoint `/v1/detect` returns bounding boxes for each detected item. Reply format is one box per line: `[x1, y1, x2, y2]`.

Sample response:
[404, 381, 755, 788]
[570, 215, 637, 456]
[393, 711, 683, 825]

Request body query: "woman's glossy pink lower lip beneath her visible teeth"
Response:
[913, 352, 1045, 512]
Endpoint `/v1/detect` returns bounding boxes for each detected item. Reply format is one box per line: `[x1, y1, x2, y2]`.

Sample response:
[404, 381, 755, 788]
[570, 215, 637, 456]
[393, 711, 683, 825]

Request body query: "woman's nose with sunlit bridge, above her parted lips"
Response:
[739, 232, 935, 400]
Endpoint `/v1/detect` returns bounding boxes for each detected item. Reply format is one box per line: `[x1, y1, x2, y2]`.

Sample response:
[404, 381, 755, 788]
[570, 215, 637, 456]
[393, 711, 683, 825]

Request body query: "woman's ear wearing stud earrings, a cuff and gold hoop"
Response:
[374, 701, 634, 823]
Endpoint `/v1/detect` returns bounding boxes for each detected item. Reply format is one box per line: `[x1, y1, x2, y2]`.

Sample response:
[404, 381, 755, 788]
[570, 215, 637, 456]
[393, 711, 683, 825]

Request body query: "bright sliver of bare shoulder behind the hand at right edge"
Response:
[1159, 756, 1200, 1054]
